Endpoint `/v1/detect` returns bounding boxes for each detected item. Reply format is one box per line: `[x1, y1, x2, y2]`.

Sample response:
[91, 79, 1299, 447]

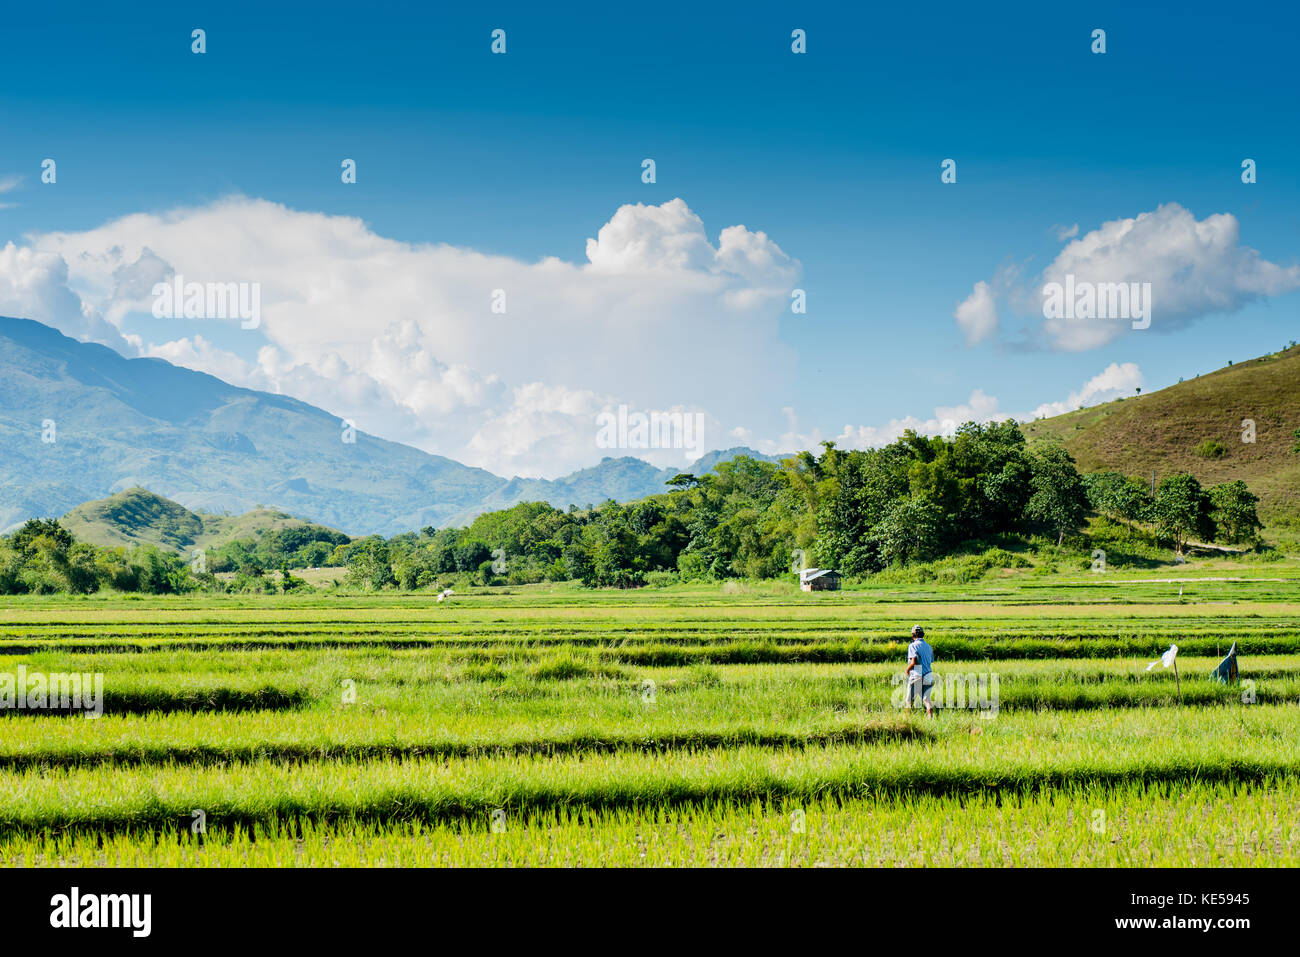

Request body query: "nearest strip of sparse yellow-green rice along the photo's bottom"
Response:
[0, 780, 1300, 867]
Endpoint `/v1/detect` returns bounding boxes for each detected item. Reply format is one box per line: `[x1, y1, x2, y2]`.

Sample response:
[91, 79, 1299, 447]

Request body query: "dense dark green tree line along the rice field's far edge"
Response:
[0, 420, 1262, 594]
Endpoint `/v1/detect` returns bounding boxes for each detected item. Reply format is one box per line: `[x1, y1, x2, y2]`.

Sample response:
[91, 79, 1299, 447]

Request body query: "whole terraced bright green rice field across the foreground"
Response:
[0, 572, 1300, 867]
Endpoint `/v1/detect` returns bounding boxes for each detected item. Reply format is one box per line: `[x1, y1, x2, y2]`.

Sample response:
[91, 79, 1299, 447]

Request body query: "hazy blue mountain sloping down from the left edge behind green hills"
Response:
[0, 317, 780, 534]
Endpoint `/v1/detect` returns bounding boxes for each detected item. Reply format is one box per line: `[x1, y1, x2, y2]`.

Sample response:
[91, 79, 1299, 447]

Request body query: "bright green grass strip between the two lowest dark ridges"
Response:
[0, 705, 1300, 833]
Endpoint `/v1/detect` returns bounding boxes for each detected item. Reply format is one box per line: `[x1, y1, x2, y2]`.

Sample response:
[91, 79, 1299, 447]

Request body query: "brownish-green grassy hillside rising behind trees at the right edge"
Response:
[1023, 346, 1300, 538]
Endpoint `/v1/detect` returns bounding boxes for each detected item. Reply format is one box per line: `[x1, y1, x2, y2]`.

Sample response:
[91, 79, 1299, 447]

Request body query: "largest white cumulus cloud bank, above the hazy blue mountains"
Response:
[15, 196, 801, 475]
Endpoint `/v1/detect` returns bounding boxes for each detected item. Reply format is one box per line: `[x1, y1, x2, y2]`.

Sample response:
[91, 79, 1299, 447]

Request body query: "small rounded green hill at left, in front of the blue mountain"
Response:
[59, 488, 348, 553]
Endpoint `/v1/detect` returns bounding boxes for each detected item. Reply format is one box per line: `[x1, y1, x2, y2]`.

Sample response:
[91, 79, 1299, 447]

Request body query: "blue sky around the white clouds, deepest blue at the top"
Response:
[0, 3, 1300, 473]
